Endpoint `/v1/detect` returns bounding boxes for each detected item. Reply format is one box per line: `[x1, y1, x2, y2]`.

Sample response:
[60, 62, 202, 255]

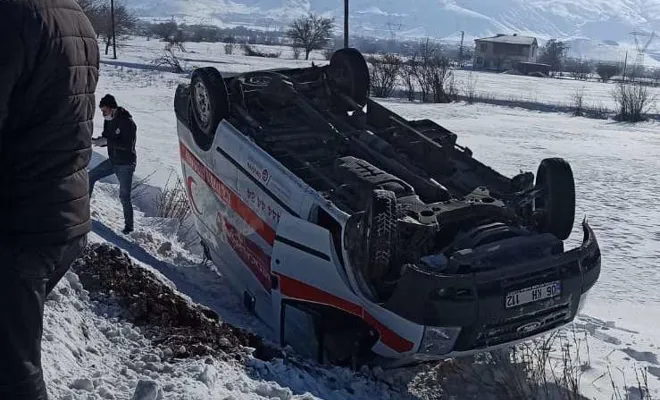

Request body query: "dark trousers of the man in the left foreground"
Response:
[0, 236, 87, 400]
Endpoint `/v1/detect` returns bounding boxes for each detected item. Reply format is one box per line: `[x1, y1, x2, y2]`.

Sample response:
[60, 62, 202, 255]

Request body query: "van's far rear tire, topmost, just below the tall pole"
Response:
[328, 48, 371, 107]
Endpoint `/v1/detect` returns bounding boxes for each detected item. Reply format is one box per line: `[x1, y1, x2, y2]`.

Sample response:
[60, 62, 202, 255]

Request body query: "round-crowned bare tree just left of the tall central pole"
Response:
[286, 13, 335, 60]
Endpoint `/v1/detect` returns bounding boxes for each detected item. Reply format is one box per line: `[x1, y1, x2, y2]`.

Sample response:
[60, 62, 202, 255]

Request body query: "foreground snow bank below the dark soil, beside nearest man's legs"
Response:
[43, 247, 387, 400]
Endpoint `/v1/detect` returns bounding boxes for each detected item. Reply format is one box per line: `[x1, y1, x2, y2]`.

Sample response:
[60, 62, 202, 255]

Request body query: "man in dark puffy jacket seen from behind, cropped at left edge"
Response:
[0, 0, 99, 400]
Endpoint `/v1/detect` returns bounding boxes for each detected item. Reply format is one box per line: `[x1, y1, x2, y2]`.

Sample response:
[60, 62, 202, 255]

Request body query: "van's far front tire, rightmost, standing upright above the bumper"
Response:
[534, 158, 575, 240]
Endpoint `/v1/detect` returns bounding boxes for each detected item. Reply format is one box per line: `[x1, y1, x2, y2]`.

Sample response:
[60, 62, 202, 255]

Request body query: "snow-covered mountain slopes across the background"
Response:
[128, 0, 660, 41]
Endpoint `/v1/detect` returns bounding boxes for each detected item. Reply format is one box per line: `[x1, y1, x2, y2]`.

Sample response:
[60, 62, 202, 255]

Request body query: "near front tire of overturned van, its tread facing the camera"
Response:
[364, 189, 399, 280]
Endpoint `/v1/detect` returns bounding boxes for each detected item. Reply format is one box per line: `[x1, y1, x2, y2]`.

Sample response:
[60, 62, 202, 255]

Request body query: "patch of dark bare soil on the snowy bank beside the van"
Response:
[72, 244, 283, 361]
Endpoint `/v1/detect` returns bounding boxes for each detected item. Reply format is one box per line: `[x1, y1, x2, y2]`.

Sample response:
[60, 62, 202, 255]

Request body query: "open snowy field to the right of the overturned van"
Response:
[383, 101, 660, 398]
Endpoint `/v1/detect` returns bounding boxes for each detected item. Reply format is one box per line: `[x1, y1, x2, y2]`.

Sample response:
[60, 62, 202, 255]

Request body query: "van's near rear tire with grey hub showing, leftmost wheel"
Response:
[190, 67, 230, 137]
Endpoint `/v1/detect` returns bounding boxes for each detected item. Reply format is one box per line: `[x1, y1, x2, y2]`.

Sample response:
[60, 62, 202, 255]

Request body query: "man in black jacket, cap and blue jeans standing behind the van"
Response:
[89, 94, 137, 234]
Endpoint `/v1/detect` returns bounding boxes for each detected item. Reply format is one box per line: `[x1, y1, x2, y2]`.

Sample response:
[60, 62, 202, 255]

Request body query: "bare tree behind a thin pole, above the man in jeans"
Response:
[91, 0, 138, 55]
